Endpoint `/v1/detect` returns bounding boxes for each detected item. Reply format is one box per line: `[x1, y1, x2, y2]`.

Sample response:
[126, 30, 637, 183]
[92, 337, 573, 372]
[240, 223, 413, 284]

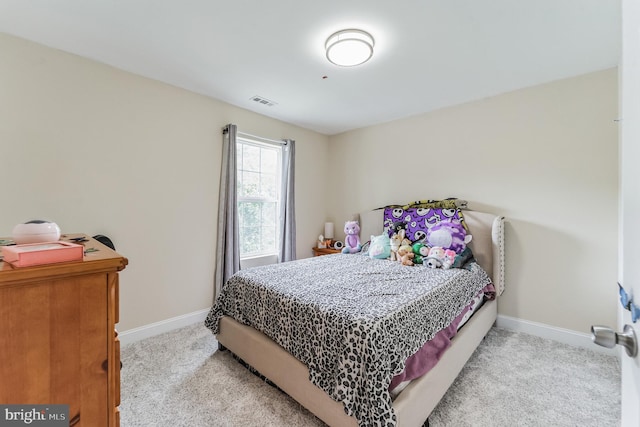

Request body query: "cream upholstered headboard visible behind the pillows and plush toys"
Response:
[360, 209, 504, 295]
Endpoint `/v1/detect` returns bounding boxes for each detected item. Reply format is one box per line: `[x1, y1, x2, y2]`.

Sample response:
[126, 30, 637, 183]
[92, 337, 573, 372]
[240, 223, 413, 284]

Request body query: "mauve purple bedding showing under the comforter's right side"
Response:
[389, 285, 495, 390]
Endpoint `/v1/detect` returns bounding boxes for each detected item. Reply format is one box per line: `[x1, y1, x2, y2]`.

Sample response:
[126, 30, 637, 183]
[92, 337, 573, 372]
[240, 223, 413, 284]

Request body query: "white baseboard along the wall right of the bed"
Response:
[496, 314, 619, 356]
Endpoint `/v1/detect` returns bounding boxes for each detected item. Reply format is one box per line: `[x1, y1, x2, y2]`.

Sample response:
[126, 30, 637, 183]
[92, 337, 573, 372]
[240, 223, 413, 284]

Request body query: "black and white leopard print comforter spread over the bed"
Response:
[205, 254, 491, 427]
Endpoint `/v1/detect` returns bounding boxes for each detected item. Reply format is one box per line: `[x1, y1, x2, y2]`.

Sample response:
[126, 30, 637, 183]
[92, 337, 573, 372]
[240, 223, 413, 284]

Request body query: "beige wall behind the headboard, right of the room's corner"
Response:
[328, 69, 618, 333]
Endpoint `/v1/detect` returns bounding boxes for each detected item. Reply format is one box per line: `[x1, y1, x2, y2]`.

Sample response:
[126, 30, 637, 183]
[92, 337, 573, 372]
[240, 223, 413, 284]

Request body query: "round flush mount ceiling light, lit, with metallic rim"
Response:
[324, 29, 374, 67]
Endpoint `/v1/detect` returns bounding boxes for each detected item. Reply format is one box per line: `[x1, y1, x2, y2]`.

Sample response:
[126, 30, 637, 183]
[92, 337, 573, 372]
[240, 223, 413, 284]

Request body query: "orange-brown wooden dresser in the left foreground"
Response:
[0, 234, 128, 427]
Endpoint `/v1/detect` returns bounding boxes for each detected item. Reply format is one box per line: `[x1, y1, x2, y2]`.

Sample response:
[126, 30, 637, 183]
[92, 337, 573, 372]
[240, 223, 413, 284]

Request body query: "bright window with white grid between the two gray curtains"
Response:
[236, 138, 282, 258]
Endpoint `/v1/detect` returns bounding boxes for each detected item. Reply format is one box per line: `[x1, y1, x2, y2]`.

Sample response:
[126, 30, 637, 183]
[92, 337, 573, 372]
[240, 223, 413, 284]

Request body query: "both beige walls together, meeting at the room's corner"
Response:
[0, 30, 618, 338]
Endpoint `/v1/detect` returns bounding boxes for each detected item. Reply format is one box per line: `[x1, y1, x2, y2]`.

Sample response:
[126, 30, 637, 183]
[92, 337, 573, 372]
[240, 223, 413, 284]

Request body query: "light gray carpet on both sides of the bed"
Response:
[120, 324, 620, 427]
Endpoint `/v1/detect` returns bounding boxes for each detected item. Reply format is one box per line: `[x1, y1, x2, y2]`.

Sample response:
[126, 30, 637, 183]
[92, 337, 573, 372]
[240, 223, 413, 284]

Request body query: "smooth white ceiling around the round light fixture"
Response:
[0, 0, 620, 135]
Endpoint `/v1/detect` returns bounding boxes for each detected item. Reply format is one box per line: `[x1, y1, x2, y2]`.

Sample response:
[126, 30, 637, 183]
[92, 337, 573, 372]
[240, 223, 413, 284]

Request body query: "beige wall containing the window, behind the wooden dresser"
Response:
[0, 34, 328, 331]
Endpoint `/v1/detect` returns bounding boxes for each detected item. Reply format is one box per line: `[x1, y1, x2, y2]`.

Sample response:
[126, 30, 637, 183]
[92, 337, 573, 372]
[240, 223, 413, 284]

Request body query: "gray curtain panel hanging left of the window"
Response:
[213, 124, 240, 301]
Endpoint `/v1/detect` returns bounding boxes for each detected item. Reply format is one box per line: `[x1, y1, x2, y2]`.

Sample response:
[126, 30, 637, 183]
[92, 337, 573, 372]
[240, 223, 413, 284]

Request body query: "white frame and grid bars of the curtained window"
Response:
[236, 136, 282, 264]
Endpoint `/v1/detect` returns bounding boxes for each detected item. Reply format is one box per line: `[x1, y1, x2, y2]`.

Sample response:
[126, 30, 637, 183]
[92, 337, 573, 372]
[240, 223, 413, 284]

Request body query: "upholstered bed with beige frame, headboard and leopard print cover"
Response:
[205, 206, 504, 427]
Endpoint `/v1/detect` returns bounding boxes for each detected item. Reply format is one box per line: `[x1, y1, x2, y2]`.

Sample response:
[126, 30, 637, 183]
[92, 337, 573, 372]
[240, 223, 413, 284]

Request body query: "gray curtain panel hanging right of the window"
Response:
[279, 139, 296, 262]
